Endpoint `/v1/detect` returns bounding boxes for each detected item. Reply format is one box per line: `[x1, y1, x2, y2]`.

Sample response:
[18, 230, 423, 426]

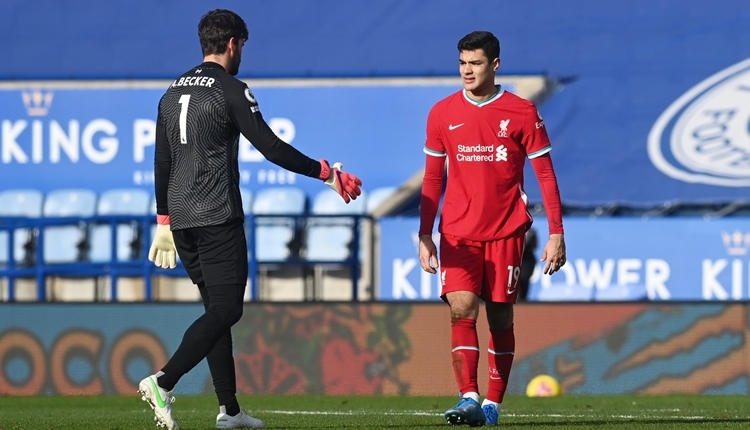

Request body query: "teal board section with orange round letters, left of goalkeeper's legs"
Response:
[0, 303, 210, 395]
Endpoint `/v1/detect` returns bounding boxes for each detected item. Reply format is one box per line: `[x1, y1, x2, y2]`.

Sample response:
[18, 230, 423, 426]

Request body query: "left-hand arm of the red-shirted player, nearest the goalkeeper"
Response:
[419, 111, 447, 273]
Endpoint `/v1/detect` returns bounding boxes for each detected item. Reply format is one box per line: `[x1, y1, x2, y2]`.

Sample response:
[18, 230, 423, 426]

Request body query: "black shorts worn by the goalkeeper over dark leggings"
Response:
[172, 219, 248, 287]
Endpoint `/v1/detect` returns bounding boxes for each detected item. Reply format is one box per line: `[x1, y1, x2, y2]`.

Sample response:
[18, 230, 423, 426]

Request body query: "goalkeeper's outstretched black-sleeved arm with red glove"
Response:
[224, 80, 362, 203]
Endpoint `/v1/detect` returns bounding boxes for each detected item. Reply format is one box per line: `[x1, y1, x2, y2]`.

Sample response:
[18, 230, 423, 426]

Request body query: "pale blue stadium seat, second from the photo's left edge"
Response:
[42, 189, 96, 263]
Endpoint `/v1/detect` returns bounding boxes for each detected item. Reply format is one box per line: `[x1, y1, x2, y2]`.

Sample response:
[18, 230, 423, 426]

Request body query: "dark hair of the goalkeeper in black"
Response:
[198, 9, 248, 56]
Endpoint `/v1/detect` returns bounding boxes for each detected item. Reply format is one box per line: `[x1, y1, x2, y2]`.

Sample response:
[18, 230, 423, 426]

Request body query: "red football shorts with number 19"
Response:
[440, 229, 525, 303]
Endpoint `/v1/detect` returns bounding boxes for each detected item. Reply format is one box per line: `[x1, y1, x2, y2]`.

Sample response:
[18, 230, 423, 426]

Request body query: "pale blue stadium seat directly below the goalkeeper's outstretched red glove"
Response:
[305, 190, 367, 261]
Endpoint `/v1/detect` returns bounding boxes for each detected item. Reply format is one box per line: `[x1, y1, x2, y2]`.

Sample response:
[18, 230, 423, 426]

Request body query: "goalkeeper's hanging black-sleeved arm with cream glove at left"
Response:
[148, 109, 177, 269]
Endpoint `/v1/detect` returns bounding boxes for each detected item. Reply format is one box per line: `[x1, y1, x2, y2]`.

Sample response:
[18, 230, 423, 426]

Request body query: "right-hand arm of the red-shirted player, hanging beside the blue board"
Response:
[523, 105, 566, 274]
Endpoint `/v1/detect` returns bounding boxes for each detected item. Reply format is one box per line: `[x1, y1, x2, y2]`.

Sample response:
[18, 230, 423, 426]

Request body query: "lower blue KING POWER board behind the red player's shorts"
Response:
[380, 217, 750, 301]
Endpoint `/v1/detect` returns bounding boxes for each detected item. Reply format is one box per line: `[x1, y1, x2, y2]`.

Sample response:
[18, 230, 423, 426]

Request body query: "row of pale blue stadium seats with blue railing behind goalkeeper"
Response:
[0, 186, 394, 300]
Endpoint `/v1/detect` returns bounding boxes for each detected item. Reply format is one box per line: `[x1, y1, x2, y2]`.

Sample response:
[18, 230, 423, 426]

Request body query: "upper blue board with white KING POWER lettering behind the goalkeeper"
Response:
[0, 79, 513, 200]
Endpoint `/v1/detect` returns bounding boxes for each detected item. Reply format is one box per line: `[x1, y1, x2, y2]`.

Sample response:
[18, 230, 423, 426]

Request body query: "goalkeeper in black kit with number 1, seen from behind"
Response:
[139, 10, 362, 429]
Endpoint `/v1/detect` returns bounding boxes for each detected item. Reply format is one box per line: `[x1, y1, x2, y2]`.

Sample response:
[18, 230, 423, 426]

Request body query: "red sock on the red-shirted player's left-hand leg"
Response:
[451, 318, 479, 394]
